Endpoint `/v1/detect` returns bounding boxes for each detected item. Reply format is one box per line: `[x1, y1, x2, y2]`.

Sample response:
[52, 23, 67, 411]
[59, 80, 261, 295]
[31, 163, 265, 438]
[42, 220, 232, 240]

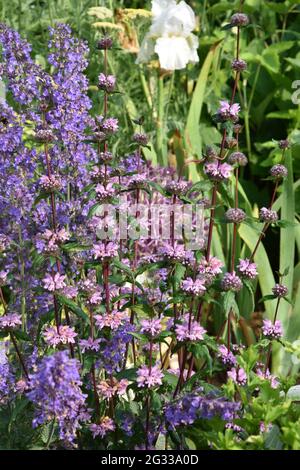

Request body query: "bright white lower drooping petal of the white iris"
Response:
[154, 36, 198, 70]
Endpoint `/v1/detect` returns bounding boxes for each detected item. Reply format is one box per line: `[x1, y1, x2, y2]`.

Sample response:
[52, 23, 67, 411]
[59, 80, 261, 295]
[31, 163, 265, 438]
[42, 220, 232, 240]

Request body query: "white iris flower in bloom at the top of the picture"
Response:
[137, 0, 199, 70]
